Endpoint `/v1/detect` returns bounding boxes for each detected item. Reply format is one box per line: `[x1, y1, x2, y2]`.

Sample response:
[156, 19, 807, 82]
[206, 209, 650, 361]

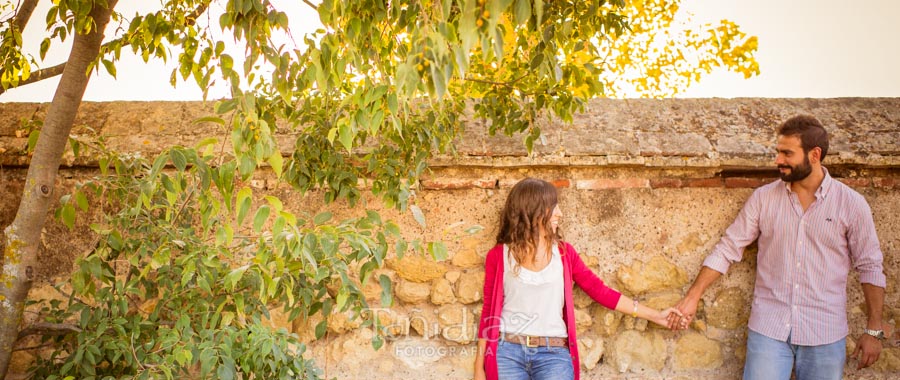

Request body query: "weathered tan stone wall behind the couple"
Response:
[0, 99, 900, 379]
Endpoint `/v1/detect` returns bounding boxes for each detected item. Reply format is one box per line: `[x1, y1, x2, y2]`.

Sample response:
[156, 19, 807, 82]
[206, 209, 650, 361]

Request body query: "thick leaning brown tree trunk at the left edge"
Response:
[0, 0, 117, 378]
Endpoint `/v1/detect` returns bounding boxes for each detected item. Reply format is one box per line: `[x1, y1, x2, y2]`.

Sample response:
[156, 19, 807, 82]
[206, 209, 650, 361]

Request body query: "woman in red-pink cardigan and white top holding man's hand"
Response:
[475, 178, 680, 380]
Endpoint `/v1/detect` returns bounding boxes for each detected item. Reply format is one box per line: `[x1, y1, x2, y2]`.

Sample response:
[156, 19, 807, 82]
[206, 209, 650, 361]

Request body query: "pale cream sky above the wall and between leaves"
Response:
[0, 0, 900, 102]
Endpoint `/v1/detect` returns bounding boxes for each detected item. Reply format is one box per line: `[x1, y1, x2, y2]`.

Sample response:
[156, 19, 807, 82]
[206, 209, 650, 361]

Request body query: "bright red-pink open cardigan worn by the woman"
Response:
[478, 242, 622, 380]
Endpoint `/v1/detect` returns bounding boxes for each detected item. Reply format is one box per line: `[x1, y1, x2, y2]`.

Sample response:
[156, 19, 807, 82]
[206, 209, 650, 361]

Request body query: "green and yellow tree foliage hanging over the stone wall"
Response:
[0, 0, 758, 379]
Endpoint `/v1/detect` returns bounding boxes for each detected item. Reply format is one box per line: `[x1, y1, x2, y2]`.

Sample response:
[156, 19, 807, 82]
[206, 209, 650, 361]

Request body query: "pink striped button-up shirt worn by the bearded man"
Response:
[703, 167, 885, 346]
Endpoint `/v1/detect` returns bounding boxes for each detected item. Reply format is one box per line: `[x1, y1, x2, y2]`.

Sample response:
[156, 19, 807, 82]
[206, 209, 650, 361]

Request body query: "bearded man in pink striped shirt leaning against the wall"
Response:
[670, 116, 885, 380]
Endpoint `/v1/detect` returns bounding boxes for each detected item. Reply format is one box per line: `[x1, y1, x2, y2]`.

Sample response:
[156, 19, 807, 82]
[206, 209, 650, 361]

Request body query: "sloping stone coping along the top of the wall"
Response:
[0, 98, 900, 169]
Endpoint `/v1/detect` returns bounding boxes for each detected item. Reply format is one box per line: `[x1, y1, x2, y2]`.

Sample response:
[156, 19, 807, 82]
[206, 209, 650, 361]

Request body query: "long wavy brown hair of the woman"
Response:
[497, 178, 562, 274]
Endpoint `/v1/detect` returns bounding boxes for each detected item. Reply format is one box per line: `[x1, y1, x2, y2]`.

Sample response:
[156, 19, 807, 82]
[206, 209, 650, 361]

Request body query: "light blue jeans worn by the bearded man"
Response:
[744, 330, 847, 380]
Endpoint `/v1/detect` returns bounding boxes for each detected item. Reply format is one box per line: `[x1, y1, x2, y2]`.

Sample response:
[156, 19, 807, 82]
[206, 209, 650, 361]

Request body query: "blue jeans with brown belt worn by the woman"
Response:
[497, 340, 575, 380]
